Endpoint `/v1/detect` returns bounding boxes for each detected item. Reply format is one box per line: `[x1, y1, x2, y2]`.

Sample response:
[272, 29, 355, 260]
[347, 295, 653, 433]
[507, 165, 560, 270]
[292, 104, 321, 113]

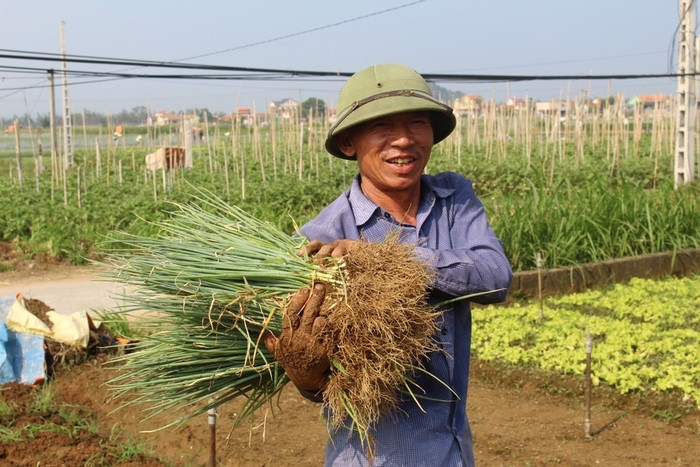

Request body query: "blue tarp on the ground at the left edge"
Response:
[0, 298, 46, 384]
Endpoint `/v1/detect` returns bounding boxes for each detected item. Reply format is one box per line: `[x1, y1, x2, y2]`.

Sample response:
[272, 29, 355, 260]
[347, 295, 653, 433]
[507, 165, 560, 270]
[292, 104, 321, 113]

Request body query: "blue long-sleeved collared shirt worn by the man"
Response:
[300, 172, 513, 466]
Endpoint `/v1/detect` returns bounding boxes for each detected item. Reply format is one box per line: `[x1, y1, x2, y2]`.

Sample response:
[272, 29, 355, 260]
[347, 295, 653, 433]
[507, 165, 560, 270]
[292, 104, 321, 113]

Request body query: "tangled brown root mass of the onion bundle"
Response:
[324, 236, 436, 441]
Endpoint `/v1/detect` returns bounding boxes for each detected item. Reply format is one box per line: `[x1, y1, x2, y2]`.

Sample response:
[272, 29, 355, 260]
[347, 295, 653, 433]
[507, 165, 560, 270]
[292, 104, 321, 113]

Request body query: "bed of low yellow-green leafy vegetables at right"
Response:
[472, 276, 700, 406]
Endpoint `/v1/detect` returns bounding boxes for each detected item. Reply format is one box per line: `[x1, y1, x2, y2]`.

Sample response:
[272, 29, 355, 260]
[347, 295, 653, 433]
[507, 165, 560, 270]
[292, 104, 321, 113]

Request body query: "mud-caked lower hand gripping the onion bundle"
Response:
[264, 284, 331, 394]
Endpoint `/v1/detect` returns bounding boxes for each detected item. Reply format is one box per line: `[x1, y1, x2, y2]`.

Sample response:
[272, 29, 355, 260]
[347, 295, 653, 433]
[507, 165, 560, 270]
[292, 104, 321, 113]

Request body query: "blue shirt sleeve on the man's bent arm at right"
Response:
[416, 179, 513, 303]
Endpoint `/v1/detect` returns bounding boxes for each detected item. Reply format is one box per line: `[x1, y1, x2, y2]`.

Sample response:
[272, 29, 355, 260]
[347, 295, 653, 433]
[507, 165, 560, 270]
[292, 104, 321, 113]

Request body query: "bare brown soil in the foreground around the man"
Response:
[0, 264, 700, 467]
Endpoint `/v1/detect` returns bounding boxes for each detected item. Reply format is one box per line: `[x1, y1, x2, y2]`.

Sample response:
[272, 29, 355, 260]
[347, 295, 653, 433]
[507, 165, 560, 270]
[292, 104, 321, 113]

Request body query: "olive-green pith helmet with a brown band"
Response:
[326, 64, 455, 159]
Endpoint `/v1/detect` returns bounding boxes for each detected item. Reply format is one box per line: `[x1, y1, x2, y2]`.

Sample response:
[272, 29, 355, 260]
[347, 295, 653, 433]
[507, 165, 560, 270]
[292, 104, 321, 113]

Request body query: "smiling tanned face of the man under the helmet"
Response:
[338, 112, 433, 195]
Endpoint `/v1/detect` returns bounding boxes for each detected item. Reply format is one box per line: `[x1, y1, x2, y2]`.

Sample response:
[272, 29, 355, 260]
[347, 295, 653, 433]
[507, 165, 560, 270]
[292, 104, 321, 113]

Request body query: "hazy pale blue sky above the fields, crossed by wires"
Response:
[0, 0, 680, 118]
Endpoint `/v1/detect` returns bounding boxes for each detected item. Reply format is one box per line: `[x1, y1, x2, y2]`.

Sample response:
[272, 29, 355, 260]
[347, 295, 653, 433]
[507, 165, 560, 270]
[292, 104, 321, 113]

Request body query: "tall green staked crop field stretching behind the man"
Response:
[0, 101, 700, 270]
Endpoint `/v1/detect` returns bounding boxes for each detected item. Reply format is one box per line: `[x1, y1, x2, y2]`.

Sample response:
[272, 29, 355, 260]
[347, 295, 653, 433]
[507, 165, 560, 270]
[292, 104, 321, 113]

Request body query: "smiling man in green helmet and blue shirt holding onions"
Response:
[266, 64, 512, 466]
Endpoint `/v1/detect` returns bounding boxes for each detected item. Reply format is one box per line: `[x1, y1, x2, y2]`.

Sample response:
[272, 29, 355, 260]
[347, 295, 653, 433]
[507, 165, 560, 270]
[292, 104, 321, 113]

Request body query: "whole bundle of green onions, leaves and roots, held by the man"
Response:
[105, 187, 437, 455]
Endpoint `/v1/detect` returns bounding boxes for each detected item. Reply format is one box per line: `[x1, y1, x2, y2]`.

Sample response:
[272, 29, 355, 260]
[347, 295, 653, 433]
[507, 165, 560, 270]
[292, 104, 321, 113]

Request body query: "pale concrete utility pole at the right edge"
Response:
[674, 0, 697, 188]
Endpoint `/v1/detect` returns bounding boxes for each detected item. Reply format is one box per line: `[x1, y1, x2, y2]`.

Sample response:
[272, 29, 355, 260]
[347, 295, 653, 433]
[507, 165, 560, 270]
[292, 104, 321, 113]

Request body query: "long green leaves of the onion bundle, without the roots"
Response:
[105, 193, 339, 426]
